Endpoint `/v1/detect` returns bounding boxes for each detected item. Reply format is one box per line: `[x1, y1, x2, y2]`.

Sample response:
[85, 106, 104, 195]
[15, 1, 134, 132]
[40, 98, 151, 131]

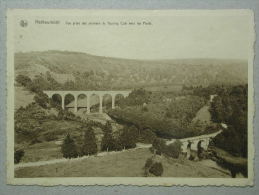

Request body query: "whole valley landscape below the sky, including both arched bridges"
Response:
[15, 51, 250, 177]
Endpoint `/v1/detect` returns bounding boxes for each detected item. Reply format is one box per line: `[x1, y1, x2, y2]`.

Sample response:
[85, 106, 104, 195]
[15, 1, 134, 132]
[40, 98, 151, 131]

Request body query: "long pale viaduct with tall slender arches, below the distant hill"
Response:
[43, 91, 131, 113]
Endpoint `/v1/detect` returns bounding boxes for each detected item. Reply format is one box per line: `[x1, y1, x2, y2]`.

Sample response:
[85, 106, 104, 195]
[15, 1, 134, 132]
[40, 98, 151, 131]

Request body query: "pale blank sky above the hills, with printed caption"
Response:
[14, 9, 252, 59]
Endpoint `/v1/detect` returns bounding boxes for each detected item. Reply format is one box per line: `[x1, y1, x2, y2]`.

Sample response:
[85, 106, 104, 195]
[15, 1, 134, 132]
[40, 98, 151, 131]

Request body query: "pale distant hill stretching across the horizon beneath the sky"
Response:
[15, 51, 247, 89]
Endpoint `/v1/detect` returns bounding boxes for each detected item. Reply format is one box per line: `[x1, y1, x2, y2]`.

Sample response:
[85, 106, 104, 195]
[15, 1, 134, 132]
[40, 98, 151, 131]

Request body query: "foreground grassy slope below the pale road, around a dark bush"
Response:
[15, 148, 230, 178]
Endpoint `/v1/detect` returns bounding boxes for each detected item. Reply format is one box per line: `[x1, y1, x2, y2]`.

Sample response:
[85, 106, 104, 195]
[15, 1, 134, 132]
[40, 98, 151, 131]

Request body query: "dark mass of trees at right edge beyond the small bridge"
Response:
[210, 85, 248, 157]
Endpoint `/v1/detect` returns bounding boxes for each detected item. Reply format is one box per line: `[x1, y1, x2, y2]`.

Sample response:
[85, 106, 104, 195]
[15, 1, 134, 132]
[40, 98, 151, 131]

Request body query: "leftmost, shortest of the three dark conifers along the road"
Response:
[61, 133, 78, 158]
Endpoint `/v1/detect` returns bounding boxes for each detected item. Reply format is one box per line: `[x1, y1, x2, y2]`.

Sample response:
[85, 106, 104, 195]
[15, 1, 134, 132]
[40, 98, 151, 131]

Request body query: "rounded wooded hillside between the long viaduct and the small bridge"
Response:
[108, 89, 217, 139]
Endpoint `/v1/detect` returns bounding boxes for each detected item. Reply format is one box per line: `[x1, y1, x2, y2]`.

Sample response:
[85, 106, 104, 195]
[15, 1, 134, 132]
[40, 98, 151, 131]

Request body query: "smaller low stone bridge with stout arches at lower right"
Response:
[166, 130, 222, 152]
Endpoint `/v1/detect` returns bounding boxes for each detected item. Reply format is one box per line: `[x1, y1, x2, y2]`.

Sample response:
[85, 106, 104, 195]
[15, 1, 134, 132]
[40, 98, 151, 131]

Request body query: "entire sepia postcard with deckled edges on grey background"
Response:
[6, 9, 255, 186]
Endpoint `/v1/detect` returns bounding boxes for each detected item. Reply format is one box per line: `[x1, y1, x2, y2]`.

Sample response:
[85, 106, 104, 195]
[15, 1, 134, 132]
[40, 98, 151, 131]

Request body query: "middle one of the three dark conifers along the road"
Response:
[81, 127, 97, 155]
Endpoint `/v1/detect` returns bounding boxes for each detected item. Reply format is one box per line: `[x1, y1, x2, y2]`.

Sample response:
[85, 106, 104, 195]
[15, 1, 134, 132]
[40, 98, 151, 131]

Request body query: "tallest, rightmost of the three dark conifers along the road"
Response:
[101, 121, 116, 151]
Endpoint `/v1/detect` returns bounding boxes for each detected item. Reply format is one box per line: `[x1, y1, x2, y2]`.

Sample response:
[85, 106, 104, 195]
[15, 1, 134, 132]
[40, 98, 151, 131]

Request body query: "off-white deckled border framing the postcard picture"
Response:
[6, 9, 255, 186]
